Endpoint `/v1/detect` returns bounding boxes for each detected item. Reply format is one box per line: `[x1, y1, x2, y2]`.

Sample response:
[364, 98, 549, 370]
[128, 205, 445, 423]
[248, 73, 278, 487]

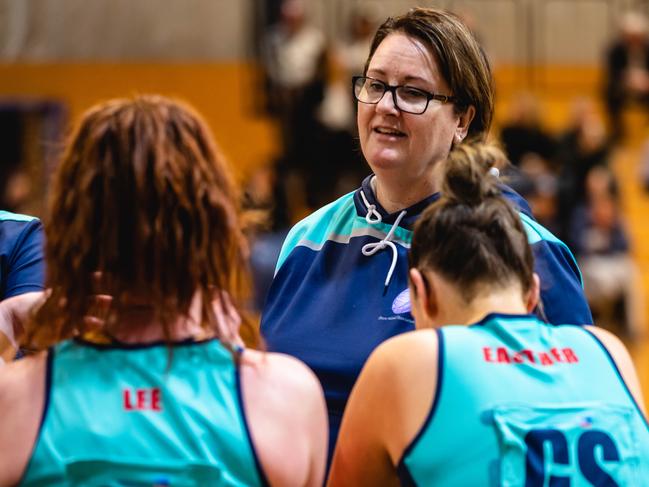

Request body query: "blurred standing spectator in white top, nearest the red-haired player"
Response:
[261, 0, 328, 211]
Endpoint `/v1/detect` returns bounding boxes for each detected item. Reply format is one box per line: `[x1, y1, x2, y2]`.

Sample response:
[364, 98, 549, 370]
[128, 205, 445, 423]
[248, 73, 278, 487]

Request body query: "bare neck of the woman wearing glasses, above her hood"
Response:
[372, 164, 441, 213]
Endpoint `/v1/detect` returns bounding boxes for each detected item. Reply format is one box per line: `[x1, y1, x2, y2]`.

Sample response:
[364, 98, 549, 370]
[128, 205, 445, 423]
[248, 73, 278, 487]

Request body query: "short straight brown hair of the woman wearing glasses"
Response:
[364, 8, 494, 140]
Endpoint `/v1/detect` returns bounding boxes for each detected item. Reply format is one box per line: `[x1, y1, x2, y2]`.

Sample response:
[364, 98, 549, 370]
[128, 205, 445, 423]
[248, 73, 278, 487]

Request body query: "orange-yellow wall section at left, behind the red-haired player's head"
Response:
[0, 63, 276, 178]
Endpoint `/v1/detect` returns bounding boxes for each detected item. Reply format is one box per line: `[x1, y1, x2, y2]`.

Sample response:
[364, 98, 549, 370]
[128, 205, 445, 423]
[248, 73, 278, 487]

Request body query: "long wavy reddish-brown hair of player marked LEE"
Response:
[24, 96, 251, 349]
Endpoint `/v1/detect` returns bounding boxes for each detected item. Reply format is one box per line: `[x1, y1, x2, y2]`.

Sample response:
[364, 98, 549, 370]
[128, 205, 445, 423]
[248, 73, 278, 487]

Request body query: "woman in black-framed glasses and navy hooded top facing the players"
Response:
[261, 8, 592, 466]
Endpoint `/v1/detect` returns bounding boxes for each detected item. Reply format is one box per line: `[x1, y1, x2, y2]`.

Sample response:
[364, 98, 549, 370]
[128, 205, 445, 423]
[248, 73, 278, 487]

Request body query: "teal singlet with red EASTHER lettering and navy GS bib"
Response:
[399, 314, 649, 487]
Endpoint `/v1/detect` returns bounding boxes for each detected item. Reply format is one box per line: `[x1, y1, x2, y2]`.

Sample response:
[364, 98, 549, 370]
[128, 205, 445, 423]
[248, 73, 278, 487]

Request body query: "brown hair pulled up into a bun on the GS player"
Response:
[410, 144, 534, 302]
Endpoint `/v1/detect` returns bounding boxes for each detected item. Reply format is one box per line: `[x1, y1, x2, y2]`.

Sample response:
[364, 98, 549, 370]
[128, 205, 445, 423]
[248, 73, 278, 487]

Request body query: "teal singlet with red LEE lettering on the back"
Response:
[22, 340, 266, 486]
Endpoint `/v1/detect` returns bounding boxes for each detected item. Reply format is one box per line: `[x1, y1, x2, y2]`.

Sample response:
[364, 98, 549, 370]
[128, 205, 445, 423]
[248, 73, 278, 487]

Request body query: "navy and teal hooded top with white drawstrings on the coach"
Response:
[261, 176, 592, 453]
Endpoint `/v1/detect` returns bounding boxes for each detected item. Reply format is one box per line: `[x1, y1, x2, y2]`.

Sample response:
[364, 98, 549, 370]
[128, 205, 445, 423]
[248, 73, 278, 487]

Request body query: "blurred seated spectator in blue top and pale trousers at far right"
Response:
[572, 166, 645, 338]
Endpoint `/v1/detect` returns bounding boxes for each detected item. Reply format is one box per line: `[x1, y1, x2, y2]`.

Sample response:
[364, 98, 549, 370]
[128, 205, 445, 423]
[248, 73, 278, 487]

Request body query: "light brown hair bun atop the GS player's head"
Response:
[442, 143, 507, 206]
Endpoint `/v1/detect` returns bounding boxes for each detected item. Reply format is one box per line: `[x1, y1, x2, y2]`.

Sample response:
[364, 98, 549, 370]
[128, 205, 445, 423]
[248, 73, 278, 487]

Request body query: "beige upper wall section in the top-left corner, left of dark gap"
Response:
[0, 0, 252, 62]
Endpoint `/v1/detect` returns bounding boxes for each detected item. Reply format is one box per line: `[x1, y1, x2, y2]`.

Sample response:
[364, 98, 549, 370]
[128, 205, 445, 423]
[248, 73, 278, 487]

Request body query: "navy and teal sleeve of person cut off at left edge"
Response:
[0, 210, 45, 300]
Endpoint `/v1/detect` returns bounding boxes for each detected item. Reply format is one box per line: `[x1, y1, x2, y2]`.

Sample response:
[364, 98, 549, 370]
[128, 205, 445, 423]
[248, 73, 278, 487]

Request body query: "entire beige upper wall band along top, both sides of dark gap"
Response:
[0, 0, 649, 65]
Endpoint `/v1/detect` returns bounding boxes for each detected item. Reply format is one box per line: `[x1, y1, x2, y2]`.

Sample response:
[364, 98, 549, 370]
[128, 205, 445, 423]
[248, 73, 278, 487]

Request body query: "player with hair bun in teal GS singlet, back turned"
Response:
[329, 144, 649, 487]
